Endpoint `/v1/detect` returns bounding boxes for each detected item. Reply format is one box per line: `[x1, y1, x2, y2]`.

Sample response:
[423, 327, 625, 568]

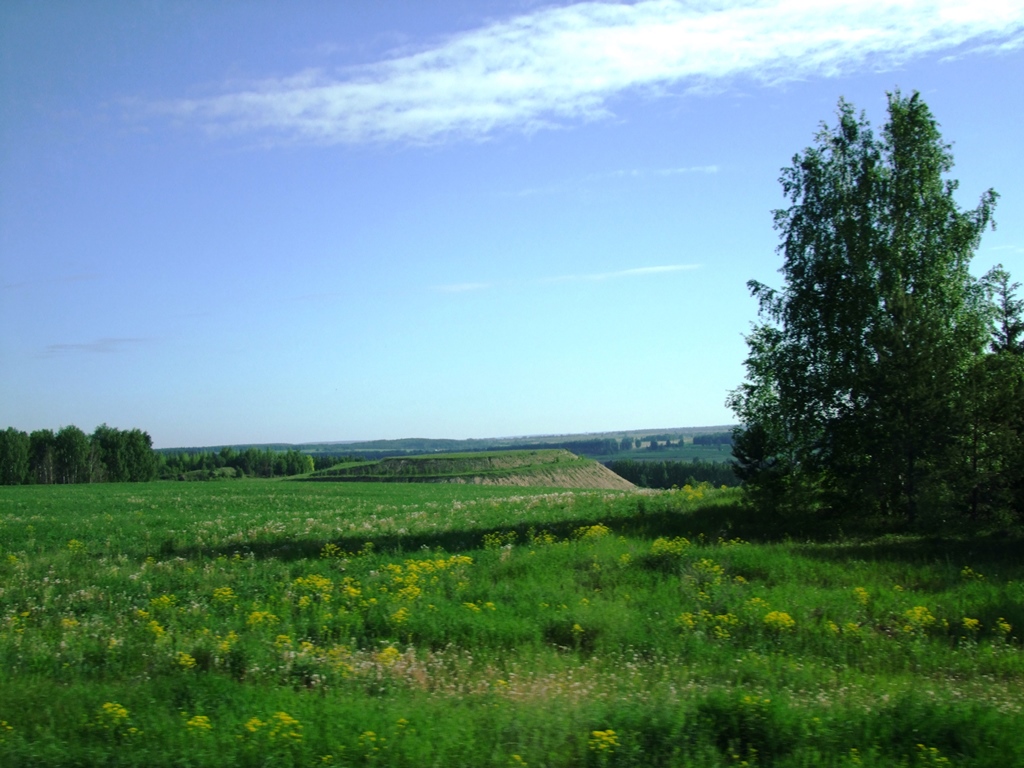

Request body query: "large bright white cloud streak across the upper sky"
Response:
[153, 0, 1024, 144]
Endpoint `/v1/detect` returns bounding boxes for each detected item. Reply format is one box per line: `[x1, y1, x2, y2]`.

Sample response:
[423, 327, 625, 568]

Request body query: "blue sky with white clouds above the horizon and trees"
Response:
[0, 0, 1024, 446]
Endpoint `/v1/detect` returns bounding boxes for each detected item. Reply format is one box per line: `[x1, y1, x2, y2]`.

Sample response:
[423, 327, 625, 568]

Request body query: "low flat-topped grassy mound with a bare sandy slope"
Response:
[308, 450, 633, 489]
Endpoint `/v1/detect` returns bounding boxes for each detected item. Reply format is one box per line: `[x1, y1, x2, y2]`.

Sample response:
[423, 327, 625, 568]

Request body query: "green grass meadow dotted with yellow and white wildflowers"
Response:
[0, 480, 1024, 768]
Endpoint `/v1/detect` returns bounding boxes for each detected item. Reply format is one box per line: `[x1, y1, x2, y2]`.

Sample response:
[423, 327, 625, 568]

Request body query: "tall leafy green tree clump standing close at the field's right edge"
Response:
[728, 92, 1024, 522]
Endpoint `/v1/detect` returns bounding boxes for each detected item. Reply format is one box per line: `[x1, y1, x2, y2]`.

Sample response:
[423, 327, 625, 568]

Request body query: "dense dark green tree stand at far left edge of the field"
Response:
[0, 424, 157, 485]
